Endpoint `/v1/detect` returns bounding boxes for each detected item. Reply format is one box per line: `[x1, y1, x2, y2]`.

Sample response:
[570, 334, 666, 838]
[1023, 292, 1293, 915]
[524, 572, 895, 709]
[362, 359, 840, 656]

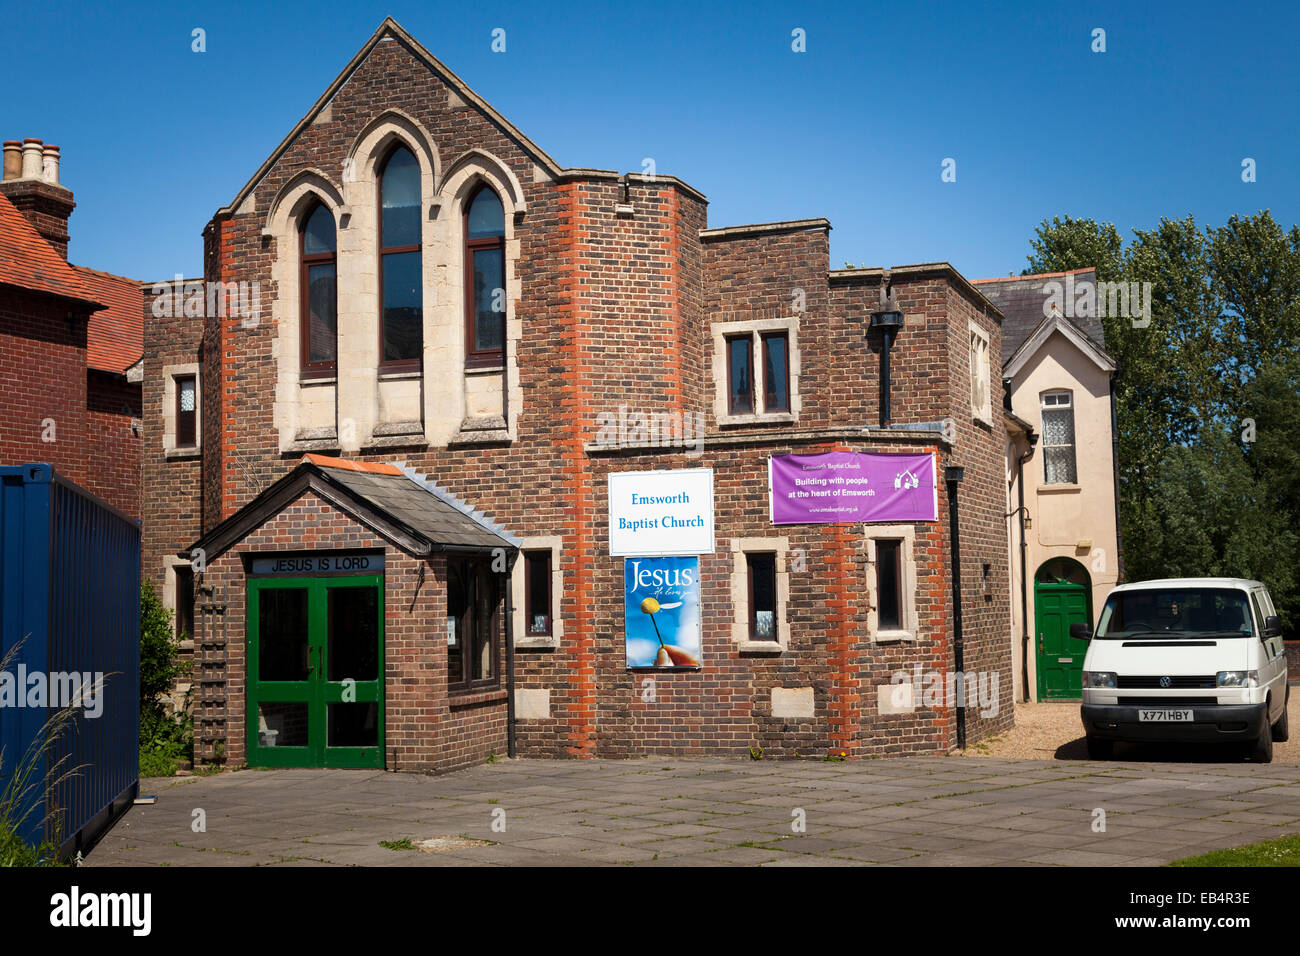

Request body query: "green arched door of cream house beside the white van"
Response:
[1034, 558, 1092, 700]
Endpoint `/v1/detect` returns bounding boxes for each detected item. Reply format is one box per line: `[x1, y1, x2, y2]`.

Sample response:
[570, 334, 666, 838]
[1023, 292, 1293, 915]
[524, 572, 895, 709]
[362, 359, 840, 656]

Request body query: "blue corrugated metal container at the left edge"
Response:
[0, 464, 140, 855]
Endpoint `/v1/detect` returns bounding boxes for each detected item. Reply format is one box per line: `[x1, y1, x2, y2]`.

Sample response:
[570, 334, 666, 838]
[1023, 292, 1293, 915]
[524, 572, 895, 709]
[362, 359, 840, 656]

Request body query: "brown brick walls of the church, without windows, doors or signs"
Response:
[143, 22, 1014, 771]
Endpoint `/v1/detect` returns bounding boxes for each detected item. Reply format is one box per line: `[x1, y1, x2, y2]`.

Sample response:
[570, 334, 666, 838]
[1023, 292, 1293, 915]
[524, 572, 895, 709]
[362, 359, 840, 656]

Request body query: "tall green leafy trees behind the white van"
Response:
[1026, 211, 1300, 636]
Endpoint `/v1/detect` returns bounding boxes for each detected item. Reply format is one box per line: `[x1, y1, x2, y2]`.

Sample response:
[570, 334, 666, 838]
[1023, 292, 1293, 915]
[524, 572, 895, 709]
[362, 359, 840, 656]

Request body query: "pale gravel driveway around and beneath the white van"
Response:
[967, 693, 1300, 763]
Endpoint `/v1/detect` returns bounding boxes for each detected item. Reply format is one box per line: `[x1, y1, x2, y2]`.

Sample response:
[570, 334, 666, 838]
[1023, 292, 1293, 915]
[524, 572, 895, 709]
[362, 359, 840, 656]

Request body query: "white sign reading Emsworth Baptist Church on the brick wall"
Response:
[610, 468, 714, 557]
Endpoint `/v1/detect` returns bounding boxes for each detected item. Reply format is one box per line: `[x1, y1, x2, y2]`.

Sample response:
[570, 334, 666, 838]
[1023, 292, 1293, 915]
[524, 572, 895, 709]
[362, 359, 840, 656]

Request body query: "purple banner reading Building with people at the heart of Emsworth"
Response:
[767, 451, 939, 524]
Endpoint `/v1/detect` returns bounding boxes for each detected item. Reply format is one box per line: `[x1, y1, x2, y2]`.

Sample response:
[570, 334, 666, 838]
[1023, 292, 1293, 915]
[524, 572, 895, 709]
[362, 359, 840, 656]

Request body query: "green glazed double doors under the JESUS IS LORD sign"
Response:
[247, 575, 384, 767]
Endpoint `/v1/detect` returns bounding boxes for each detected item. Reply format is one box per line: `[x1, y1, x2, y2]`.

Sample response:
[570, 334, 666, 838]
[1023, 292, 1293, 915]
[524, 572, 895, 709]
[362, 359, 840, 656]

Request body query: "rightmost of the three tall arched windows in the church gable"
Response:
[465, 186, 506, 367]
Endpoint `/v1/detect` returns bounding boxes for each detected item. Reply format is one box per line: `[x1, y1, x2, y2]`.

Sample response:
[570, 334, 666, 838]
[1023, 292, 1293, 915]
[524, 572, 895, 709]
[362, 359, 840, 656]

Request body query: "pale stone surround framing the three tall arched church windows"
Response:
[263, 109, 527, 453]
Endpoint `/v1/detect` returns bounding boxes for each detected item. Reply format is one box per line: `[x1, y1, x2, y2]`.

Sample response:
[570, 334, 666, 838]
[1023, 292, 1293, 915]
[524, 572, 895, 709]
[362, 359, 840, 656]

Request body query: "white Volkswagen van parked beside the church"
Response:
[1070, 578, 1288, 763]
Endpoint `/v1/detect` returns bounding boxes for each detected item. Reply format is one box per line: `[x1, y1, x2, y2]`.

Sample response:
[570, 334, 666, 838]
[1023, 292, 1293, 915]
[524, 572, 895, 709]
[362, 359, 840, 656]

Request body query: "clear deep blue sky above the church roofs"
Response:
[0, 0, 1300, 280]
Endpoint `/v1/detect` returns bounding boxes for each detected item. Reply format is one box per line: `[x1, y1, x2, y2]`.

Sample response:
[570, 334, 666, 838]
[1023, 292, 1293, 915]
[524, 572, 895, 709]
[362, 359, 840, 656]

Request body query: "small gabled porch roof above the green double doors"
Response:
[185, 455, 520, 562]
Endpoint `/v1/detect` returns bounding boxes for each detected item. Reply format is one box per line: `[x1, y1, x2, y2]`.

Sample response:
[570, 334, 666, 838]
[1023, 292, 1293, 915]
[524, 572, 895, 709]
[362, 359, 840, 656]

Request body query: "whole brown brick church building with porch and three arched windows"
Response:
[143, 20, 1014, 771]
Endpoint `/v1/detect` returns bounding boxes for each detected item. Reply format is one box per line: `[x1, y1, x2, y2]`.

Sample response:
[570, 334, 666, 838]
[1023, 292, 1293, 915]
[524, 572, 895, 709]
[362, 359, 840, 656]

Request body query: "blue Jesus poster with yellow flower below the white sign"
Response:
[623, 557, 699, 670]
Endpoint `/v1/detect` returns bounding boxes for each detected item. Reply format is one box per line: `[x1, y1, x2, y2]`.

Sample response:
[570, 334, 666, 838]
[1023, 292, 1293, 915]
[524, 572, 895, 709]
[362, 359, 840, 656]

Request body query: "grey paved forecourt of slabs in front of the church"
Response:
[86, 757, 1300, 866]
